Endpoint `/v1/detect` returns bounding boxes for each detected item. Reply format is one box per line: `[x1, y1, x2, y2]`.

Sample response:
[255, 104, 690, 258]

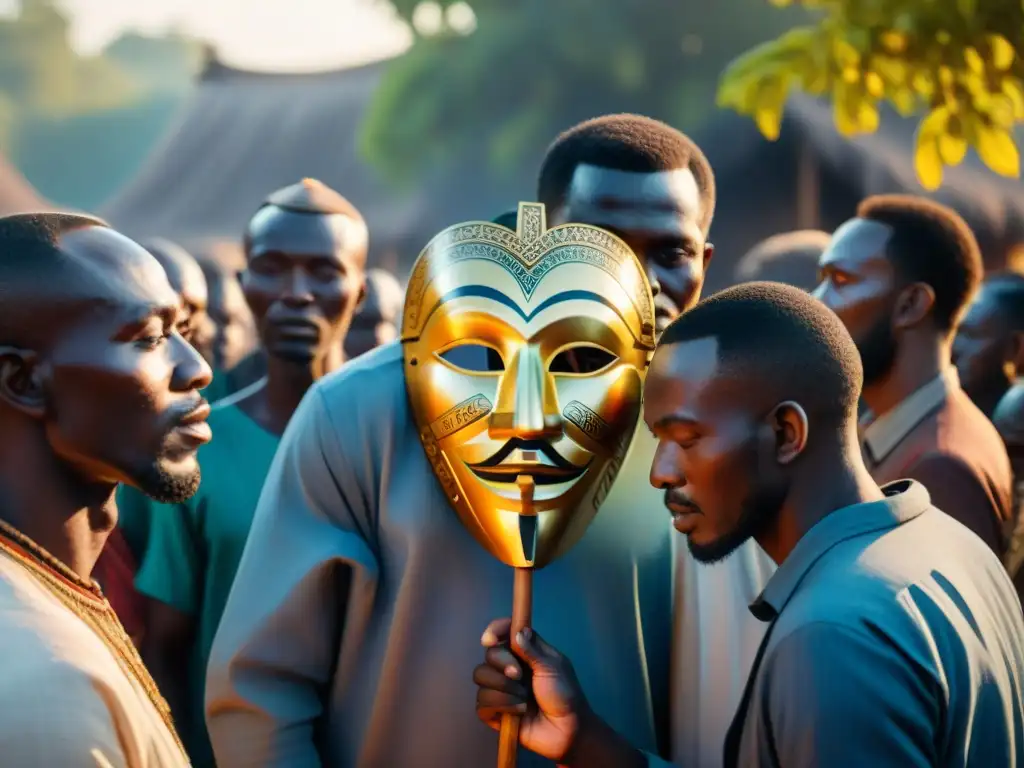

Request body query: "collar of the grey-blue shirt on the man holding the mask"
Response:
[751, 480, 932, 622]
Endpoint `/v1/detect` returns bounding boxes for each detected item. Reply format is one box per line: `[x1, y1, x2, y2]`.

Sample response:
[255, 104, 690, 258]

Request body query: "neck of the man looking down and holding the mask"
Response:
[757, 423, 885, 564]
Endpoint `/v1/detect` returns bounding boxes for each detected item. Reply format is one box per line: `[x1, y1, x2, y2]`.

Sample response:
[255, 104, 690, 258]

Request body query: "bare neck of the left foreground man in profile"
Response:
[0, 426, 118, 580]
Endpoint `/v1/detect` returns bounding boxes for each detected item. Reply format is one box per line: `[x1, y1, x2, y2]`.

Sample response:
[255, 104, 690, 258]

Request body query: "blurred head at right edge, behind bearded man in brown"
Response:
[953, 271, 1024, 418]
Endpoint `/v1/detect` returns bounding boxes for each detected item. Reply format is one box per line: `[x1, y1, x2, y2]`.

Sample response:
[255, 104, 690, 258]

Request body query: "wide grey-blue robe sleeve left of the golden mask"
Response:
[206, 385, 378, 768]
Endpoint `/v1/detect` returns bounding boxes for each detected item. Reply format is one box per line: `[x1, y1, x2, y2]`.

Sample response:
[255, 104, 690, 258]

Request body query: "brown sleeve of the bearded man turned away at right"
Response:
[906, 454, 1010, 557]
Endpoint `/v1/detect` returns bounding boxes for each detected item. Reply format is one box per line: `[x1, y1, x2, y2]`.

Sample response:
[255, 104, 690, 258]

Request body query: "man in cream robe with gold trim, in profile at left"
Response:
[0, 213, 211, 768]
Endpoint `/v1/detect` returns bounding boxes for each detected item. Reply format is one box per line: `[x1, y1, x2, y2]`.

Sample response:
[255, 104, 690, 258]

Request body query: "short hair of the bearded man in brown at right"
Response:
[857, 195, 984, 331]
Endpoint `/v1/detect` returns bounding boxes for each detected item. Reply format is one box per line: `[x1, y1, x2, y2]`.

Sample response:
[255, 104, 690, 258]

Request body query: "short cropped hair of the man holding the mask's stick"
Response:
[657, 283, 864, 425]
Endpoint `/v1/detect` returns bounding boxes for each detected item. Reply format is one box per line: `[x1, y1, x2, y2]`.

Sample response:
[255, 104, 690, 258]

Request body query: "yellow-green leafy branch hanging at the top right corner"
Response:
[718, 0, 1024, 189]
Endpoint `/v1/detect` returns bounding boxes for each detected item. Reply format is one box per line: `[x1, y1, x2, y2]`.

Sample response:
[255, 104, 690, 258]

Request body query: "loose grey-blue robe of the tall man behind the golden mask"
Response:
[207, 343, 770, 768]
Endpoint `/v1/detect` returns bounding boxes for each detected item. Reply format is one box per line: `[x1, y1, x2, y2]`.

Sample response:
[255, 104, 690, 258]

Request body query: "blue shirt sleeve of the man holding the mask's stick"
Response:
[761, 623, 940, 768]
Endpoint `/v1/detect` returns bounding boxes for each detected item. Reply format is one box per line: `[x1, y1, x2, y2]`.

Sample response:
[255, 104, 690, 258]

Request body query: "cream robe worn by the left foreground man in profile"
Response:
[0, 553, 188, 768]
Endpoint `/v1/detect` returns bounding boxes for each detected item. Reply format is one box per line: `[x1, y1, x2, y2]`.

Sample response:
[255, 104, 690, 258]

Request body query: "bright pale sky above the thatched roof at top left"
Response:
[6, 0, 411, 71]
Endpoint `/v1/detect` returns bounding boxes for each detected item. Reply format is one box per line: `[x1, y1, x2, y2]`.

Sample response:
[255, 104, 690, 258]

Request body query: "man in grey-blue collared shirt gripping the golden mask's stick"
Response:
[474, 283, 1024, 768]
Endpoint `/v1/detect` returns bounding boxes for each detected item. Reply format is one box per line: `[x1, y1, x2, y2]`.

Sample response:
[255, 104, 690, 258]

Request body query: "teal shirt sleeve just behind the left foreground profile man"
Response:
[135, 499, 203, 615]
